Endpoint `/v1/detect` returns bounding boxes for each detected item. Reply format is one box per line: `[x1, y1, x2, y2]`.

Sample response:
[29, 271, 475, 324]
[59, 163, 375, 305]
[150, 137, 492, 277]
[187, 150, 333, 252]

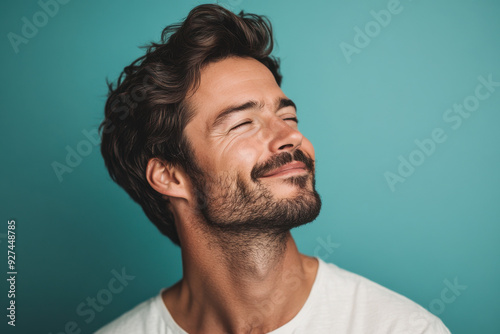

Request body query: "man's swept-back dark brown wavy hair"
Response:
[99, 4, 282, 245]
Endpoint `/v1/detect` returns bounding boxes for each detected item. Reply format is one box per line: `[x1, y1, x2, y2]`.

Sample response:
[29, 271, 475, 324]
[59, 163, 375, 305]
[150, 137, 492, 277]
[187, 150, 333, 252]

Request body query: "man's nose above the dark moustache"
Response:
[268, 117, 304, 153]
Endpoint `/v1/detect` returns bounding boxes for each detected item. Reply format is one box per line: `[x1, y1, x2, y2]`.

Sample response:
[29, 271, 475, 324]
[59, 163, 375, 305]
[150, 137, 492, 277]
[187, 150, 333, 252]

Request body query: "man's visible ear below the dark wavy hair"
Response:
[146, 158, 189, 199]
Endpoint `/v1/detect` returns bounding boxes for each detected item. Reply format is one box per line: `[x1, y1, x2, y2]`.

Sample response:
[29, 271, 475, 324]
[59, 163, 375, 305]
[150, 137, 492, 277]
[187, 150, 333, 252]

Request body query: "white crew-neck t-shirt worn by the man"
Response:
[96, 258, 450, 334]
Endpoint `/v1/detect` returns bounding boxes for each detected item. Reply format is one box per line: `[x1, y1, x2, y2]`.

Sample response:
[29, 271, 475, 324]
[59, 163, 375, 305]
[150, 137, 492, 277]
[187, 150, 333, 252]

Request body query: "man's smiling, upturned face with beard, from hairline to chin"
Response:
[184, 57, 321, 233]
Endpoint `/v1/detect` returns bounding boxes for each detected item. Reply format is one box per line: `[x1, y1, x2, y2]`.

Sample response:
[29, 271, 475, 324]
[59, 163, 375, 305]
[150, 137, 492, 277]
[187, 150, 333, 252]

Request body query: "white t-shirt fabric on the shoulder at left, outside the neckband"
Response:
[96, 296, 165, 334]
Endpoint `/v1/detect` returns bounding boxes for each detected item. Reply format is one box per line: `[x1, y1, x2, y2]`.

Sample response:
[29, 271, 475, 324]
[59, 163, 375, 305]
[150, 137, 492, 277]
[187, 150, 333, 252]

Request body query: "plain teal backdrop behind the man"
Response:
[0, 0, 500, 334]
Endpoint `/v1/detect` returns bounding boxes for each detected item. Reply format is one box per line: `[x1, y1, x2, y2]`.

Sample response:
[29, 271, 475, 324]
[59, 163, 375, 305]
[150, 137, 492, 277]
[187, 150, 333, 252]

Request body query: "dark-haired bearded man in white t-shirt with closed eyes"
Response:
[98, 5, 449, 334]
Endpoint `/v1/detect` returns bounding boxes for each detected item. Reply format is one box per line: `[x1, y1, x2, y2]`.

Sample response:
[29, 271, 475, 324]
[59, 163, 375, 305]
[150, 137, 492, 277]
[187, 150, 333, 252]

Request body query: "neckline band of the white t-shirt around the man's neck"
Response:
[155, 257, 325, 334]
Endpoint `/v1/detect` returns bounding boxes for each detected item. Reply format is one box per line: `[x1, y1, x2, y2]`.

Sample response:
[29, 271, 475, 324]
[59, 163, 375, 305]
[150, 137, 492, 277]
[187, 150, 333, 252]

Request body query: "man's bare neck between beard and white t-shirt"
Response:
[164, 207, 318, 333]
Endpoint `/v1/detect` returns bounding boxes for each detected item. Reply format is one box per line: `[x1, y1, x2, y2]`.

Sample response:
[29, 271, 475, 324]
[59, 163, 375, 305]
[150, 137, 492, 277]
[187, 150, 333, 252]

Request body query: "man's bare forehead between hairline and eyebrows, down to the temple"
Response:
[187, 57, 285, 132]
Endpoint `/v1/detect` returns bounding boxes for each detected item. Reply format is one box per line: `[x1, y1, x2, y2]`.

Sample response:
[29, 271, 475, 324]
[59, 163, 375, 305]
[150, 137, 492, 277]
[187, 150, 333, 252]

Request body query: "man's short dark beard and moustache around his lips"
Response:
[186, 150, 321, 242]
